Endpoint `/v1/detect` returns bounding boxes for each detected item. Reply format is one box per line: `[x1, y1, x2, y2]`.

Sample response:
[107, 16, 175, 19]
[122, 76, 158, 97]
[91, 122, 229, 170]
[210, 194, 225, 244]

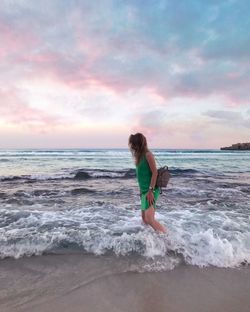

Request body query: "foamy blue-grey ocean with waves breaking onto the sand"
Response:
[0, 149, 250, 272]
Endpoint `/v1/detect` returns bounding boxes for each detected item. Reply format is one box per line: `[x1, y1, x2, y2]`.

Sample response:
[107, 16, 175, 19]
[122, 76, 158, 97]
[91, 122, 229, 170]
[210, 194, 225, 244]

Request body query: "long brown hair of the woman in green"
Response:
[128, 133, 148, 165]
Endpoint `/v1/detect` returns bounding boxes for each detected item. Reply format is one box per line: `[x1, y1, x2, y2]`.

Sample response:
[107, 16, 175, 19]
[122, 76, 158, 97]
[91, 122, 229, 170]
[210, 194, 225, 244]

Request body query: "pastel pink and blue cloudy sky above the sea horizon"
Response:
[0, 0, 250, 149]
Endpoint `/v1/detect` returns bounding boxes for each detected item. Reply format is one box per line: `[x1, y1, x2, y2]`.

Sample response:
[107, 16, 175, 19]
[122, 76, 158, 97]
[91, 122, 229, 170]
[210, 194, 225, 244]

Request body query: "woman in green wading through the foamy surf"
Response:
[128, 133, 166, 233]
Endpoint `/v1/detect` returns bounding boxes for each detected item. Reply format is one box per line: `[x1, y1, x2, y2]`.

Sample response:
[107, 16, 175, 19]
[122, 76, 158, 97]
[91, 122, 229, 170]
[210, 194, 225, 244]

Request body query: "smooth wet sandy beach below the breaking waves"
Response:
[0, 254, 250, 312]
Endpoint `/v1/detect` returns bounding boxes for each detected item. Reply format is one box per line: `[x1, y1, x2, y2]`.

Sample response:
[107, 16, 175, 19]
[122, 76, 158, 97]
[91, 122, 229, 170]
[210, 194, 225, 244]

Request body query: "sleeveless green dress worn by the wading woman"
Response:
[136, 155, 160, 210]
